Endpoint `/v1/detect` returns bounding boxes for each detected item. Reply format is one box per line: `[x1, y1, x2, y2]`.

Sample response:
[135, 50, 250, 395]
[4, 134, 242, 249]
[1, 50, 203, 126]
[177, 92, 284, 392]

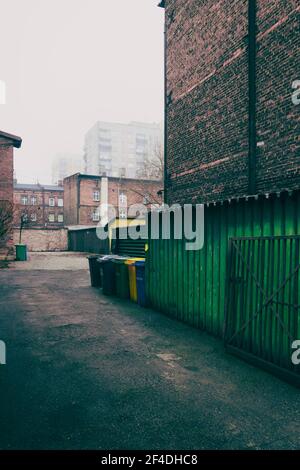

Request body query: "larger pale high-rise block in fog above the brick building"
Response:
[84, 121, 163, 178]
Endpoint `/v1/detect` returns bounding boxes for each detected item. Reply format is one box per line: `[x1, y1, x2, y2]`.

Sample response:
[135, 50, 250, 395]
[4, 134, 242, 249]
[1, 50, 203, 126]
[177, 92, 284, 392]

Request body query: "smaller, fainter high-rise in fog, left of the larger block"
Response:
[52, 153, 84, 184]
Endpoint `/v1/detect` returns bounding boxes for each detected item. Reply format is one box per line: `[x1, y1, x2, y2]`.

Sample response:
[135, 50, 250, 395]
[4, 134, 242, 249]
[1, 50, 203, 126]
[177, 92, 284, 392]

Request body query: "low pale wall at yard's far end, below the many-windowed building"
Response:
[14, 228, 68, 251]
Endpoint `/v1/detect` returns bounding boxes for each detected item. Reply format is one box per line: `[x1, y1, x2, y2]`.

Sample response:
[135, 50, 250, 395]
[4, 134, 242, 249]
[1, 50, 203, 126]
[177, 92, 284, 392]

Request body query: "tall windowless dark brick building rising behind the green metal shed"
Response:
[160, 0, 300, 203]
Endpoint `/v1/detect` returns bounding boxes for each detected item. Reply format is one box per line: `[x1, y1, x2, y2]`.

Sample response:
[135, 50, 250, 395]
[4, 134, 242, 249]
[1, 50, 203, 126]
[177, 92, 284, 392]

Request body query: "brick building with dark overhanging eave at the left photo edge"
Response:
[0, 131, 22, 256]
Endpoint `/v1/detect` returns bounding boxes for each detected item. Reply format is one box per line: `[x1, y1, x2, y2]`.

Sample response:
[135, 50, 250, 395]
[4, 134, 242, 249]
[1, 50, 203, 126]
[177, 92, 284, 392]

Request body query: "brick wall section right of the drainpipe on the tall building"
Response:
[257, 0, 300, 192]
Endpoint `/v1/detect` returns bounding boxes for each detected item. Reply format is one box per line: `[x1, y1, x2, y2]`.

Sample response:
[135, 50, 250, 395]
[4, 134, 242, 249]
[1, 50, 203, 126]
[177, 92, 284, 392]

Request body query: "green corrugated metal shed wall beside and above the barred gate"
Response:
[146, 192, 300, 337]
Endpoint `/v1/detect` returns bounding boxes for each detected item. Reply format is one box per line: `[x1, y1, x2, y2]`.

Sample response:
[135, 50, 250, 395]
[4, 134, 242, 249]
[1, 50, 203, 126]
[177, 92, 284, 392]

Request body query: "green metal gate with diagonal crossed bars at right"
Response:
[224, 235, 300, 385]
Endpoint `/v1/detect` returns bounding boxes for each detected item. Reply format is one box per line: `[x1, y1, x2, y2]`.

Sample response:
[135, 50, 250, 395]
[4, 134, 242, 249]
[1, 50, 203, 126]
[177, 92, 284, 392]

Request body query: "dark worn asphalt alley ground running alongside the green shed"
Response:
[0, 254, 300, 449]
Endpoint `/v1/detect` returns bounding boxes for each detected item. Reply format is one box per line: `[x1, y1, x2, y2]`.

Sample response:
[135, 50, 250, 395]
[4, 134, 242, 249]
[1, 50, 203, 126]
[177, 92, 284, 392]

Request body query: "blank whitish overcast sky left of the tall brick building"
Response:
[0, 0, 163, 183]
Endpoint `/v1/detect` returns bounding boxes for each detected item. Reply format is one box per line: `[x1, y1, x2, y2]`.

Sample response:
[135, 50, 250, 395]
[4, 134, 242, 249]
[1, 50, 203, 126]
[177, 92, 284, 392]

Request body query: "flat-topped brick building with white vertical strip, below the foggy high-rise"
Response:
[64, 173, 162, 225]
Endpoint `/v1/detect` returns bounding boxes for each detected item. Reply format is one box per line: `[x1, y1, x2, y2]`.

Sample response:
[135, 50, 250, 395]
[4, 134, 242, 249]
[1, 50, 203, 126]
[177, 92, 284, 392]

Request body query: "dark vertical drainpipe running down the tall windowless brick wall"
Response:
[248, 0, 257, 194]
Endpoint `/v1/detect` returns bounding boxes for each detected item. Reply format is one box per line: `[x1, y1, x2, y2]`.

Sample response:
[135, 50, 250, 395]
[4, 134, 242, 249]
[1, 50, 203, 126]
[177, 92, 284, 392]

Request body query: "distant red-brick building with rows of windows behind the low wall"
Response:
[14, 182, 64, 228]
